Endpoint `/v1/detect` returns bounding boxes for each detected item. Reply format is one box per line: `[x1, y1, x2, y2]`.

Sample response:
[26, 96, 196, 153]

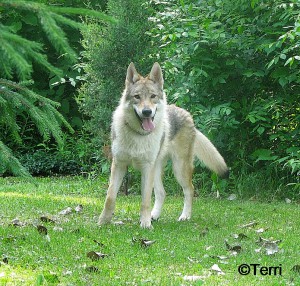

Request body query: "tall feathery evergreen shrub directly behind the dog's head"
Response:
[77, 0, 152, 152]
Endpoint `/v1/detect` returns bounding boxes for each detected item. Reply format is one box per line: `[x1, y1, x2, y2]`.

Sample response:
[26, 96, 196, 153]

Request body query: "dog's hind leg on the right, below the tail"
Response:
[172, 156, 194, 221]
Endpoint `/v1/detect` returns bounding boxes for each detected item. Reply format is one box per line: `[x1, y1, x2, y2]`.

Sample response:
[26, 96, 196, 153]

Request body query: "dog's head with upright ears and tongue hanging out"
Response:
[123, 63, 165, 132]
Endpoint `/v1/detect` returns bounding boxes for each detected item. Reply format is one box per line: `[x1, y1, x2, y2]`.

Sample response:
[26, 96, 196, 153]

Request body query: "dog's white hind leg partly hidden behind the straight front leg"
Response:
[151, 162, 166, 220]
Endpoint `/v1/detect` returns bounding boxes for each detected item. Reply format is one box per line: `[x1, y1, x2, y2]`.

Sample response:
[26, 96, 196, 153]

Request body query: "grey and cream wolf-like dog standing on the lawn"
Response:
[98, 63, 229, 228]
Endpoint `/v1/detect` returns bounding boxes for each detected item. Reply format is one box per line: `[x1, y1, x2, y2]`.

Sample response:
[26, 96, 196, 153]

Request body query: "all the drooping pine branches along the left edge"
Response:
[0, 0, 114, 177]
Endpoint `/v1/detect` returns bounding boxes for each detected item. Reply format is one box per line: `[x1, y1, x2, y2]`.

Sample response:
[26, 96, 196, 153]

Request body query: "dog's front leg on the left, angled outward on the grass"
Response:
[98, 159, 127, 225]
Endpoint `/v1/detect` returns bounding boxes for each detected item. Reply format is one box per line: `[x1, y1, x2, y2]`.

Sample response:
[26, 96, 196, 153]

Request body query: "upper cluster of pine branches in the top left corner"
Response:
[0, 0, 113, 80]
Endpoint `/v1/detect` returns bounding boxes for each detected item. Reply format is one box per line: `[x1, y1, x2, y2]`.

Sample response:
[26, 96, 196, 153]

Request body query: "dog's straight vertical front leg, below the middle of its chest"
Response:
[141, 164, 154, 228]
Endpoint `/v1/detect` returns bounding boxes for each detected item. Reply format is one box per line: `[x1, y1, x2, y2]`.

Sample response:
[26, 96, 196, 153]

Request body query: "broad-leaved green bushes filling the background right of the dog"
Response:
[151, 0, 300, 183]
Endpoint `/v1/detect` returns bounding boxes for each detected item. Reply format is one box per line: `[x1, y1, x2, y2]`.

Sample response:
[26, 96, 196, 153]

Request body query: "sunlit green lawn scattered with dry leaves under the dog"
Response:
[0, 175, 300, 285]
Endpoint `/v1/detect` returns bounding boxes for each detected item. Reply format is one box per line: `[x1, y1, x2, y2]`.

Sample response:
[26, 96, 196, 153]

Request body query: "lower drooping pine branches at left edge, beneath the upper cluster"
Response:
[0, 79, 73, 175]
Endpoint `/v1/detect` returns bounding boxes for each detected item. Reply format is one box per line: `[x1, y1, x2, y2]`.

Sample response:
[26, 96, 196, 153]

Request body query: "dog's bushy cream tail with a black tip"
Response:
[194, 130, 229, 178]
